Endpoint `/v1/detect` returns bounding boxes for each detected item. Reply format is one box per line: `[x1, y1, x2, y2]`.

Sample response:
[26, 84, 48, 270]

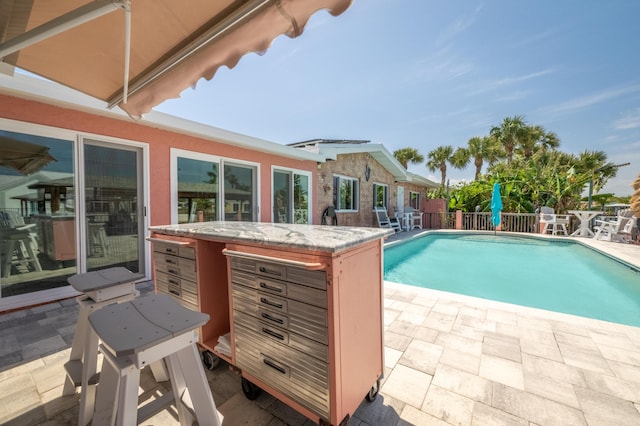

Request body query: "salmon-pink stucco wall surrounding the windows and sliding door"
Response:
[0, 94, 320, 225]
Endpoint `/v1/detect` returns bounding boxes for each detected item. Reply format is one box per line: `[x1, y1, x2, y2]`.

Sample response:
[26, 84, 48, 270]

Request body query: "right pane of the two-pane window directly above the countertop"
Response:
[224, 164, 256, 222]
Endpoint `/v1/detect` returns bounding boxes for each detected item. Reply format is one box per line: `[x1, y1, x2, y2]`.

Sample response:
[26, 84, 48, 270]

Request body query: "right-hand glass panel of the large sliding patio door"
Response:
[84, 144, 143, 272]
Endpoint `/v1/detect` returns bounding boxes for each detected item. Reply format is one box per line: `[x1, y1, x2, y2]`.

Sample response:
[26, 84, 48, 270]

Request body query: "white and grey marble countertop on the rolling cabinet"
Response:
[149, 221, 394, 252]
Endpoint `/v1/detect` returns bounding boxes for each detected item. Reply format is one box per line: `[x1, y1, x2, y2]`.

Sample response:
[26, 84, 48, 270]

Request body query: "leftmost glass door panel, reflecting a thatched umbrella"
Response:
[0, 130, 77, 298]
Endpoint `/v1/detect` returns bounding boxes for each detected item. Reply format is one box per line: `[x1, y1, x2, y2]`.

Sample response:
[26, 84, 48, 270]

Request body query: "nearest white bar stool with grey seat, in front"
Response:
[80, 294, 222, 426]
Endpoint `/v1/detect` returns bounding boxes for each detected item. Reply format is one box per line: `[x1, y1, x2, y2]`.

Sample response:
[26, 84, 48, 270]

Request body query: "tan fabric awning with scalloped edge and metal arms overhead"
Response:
[0, 0, 351, 118]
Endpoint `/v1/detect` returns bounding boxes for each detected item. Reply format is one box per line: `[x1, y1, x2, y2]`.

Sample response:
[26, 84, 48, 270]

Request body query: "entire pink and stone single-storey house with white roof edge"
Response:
[0, 72, 435, 312]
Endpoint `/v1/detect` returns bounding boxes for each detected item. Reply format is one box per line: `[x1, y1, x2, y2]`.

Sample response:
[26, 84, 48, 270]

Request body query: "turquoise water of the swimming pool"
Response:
[384, 234, 640, 326]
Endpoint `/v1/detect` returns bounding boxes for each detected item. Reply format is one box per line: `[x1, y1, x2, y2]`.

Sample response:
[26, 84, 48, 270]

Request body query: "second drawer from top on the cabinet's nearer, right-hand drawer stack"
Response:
[231, 270, 327, 308]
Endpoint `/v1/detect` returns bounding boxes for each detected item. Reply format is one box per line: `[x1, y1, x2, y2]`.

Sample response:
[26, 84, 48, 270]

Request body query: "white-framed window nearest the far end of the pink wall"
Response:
[272, 170, 310, 223]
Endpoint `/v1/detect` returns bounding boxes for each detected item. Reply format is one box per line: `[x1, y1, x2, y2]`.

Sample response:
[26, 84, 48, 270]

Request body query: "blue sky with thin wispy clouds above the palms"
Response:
[156, 0, 640, 195]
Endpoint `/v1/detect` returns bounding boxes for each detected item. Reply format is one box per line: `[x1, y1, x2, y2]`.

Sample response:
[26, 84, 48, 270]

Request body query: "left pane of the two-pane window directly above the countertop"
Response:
[178, 157, 218, 223]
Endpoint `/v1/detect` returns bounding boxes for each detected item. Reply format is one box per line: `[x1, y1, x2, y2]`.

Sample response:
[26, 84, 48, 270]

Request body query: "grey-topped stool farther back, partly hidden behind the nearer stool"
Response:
[62, 267, 144, 395]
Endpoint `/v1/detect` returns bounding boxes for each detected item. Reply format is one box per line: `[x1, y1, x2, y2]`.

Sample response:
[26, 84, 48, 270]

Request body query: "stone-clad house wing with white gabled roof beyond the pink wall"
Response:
[289, 139, 438, 226]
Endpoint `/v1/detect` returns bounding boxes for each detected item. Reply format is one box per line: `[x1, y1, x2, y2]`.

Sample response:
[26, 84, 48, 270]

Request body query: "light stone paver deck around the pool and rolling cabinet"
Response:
[0, 231, 640, 426]
